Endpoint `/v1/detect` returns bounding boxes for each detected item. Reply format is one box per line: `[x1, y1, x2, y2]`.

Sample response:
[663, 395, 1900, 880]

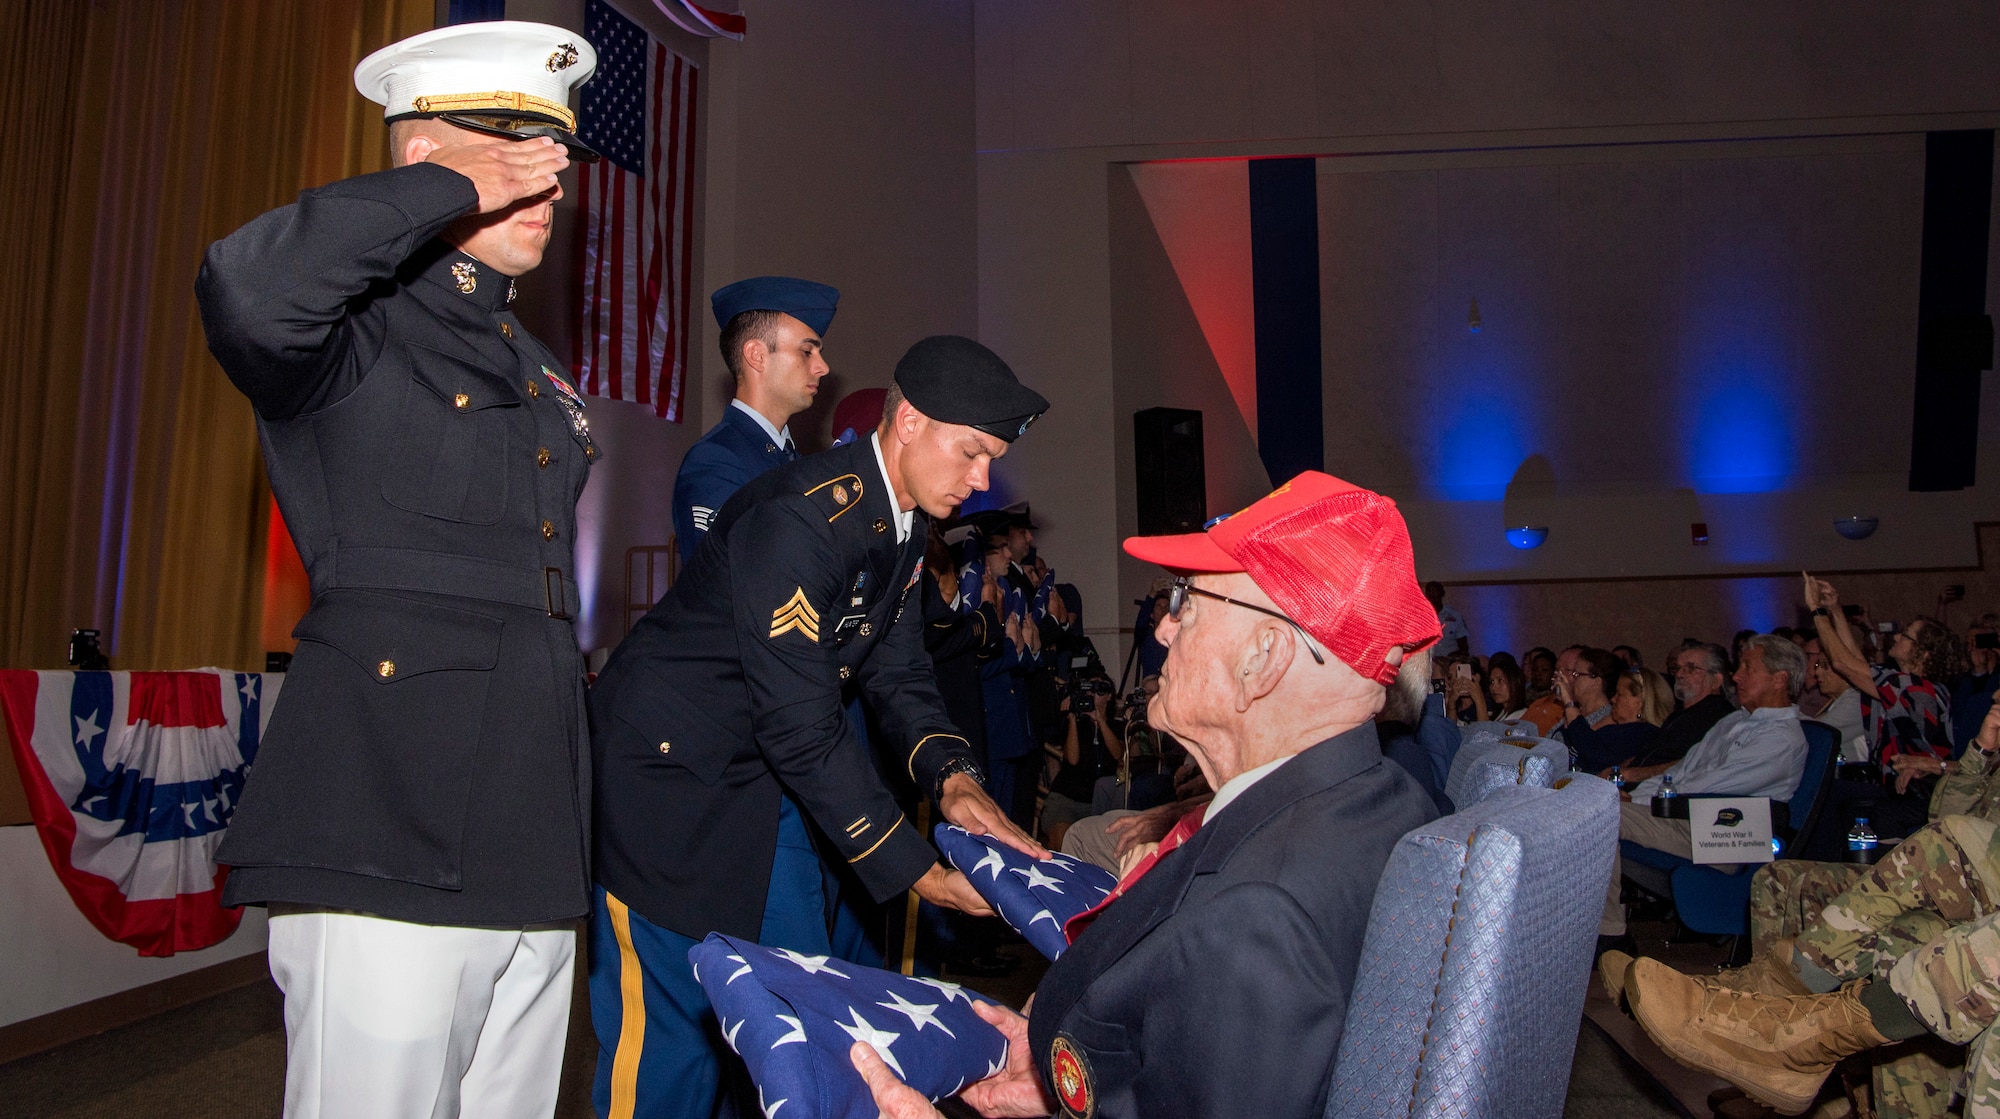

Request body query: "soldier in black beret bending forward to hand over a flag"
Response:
[590, 338, 1048, 1119]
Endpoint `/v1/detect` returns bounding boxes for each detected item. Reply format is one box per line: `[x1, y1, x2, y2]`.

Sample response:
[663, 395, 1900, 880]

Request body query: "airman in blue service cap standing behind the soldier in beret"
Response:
[674, 276, 840, 567]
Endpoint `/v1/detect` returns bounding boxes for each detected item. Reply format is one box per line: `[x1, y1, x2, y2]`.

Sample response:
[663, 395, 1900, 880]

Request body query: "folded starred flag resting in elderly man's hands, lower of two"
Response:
[688, 933, 1006, 1119]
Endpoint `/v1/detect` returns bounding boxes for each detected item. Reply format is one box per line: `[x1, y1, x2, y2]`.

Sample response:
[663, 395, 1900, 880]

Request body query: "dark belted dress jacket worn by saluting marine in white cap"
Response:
[196, 164, 596, 927]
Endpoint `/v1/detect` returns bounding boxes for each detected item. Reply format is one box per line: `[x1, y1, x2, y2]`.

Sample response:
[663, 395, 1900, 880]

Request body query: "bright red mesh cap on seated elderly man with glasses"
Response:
[1124, 470, 1442, 685]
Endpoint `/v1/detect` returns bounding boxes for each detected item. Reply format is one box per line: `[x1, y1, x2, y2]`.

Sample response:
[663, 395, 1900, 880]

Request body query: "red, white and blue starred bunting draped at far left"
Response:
[0, 669, 284, 955]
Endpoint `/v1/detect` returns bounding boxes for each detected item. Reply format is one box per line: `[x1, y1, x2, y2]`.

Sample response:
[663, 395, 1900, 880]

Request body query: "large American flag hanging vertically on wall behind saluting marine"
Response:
[570, 0, 696, 422]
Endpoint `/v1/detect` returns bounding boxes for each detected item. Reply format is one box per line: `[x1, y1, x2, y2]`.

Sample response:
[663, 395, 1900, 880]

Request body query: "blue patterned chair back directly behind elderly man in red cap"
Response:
[1326, 775, 1618, 1119]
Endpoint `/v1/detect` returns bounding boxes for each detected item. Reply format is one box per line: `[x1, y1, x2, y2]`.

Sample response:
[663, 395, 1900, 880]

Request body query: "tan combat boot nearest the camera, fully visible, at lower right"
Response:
[1626, 959, 1888, 1115]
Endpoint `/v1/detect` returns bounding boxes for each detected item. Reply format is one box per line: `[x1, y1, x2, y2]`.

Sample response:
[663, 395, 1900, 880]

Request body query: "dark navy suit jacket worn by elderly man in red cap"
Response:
[1028, 723, 1438, 1119]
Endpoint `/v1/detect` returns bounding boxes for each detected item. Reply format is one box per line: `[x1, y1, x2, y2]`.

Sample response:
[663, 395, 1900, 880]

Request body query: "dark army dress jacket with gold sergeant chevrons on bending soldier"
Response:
[590, 440, 970, 939]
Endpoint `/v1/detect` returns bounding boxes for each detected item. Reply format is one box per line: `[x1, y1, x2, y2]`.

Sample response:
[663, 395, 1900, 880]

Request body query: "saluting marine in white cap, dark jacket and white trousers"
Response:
[196, 22, 598, 1119]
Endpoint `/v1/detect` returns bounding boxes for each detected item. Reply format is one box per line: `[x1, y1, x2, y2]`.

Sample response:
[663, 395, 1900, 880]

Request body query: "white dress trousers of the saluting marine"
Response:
[270, 907, 576, 1119]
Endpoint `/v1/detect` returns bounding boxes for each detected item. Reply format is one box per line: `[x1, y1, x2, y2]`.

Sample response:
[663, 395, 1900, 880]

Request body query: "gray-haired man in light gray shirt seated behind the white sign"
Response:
[1598, 633, 1806, 941]
